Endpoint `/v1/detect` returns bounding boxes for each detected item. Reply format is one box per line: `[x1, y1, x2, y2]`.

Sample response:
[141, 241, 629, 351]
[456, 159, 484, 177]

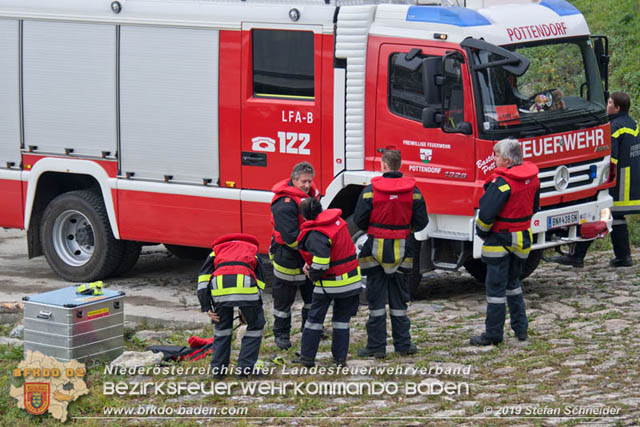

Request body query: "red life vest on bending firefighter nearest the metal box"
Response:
[212, 233, 258, 279]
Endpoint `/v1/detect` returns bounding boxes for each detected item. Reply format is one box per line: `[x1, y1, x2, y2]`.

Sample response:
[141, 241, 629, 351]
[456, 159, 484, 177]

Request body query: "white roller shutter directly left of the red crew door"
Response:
[120, 26, 219, 184]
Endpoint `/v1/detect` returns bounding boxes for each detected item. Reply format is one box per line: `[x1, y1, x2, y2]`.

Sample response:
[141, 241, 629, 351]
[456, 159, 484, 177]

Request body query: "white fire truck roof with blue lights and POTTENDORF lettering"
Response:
[0, 0, 589, 45]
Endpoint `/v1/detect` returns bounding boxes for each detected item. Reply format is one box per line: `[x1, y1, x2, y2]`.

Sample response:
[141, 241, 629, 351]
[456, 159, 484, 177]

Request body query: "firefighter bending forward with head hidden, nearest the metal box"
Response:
[198, 233, 265, 379]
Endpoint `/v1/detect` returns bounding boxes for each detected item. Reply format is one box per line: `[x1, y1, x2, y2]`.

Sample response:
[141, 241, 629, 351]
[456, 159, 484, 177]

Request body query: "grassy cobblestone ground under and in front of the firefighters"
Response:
[0, 232, 640, 425]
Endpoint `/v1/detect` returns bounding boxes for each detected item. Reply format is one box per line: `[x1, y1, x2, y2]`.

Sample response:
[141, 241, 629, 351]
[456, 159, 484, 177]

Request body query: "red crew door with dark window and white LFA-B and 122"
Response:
[241, 23, 322, 190]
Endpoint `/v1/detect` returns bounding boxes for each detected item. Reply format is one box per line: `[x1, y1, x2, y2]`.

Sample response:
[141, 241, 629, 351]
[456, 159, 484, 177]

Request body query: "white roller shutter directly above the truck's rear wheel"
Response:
[23, 21, 117, 156]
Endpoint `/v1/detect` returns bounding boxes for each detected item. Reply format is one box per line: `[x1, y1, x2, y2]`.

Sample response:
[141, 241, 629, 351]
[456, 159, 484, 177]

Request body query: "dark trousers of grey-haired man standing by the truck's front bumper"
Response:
[485, 253, 528, 341]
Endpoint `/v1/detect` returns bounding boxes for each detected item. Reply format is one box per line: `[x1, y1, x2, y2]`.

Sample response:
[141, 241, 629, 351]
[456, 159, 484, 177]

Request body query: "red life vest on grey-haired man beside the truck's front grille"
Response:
[489, 162, 540, 233]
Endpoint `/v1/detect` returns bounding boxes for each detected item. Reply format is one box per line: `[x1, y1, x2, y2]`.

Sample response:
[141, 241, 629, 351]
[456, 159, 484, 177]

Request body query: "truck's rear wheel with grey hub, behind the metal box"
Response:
[40, 190, 123, 282]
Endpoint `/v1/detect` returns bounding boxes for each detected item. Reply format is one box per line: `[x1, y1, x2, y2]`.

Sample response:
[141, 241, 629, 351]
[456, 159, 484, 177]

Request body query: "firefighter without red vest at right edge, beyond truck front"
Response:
[550, 92, 640, 268]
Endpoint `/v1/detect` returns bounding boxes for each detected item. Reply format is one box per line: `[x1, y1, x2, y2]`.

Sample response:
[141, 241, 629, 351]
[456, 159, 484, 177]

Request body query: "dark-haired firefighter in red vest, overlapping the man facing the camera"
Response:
[293, 198, 362, 367]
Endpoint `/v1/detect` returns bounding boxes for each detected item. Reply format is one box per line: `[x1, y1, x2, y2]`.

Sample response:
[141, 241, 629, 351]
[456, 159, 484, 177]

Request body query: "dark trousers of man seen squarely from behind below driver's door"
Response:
[367, 267, 411, 353]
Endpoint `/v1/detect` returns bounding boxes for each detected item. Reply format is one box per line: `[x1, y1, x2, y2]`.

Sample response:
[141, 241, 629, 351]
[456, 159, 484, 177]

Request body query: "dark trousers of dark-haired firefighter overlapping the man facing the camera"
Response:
[300, 293, 360, 361]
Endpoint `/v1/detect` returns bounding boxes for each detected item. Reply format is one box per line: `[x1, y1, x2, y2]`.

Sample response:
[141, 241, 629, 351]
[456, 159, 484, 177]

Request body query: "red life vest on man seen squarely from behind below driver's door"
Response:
[367, 176, 416, 239]
